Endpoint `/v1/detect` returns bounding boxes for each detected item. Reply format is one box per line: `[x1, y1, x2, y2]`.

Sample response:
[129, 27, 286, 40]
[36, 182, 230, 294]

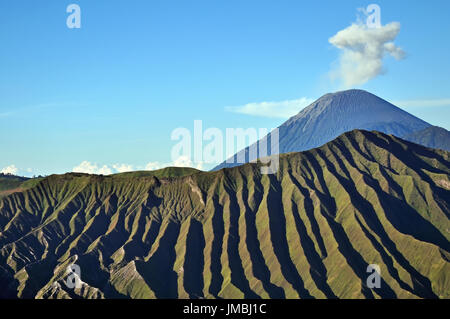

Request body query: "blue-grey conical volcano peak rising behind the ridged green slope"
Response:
[213, 90, 431, 170]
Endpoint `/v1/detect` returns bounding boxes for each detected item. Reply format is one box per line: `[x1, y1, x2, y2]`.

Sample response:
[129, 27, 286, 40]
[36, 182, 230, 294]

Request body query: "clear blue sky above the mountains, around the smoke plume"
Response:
[0, 0, 450, 175]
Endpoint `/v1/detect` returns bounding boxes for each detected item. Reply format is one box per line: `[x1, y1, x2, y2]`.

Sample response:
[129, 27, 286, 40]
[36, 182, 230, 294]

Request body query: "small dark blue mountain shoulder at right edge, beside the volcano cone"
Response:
[403, 126, 450, 151]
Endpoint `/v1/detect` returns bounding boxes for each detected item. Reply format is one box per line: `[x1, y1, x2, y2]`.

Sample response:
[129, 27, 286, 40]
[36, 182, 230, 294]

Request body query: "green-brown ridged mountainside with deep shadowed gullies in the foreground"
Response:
[0, 131, 450, 298]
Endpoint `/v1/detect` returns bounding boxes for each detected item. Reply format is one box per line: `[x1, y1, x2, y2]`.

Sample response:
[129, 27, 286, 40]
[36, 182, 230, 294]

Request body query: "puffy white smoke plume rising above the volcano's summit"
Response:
[329, 22, 405, 88]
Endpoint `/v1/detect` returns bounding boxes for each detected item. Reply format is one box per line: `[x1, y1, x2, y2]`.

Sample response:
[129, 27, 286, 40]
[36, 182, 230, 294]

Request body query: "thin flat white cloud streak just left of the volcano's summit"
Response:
[225, 97, 314, 118]
